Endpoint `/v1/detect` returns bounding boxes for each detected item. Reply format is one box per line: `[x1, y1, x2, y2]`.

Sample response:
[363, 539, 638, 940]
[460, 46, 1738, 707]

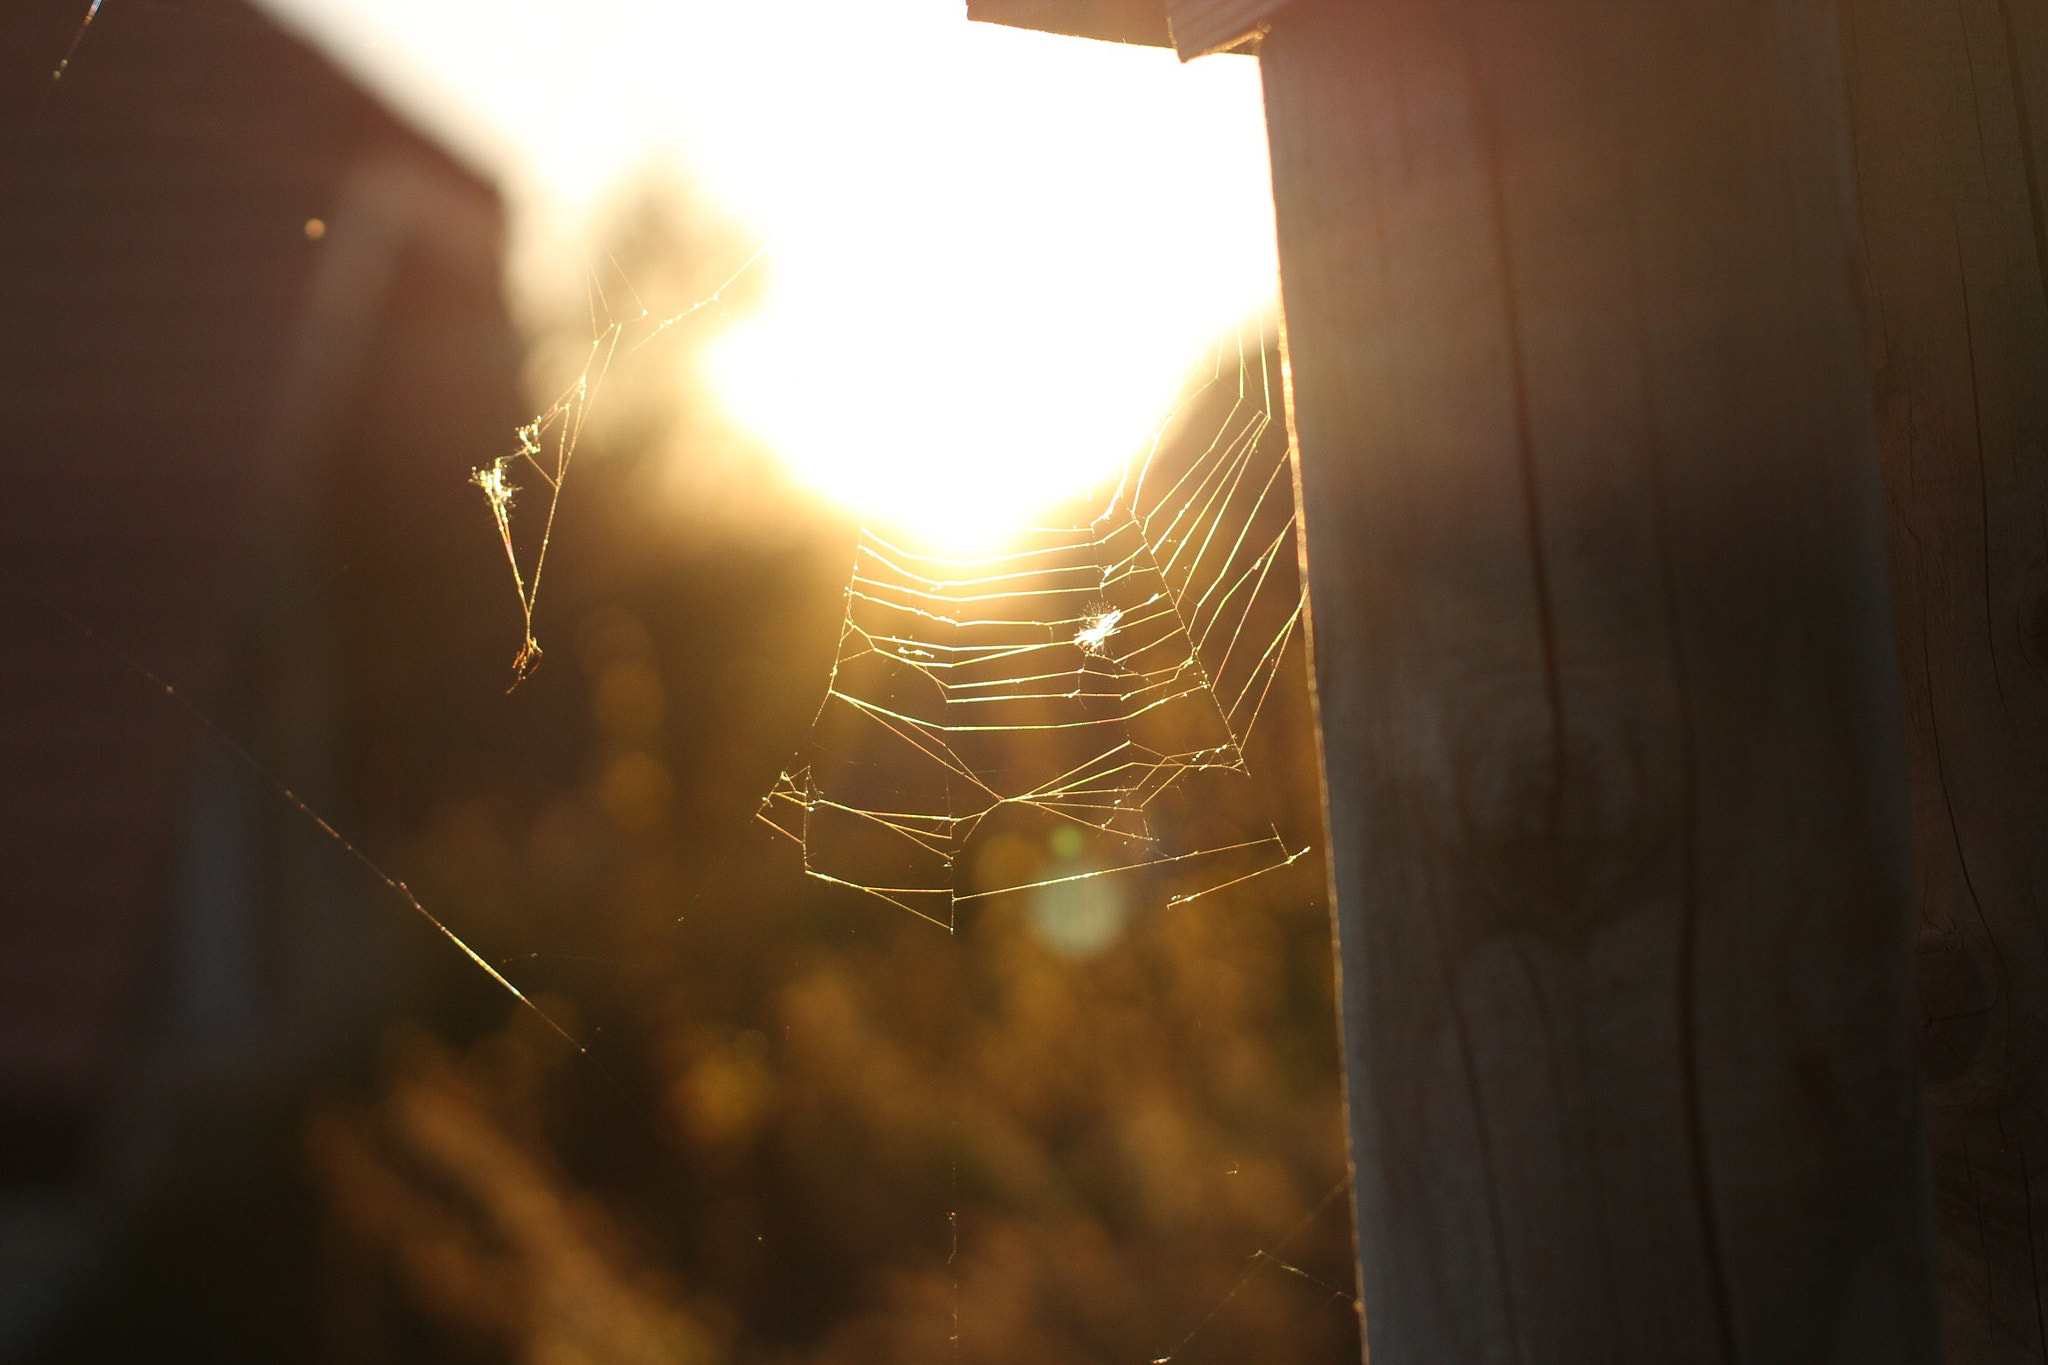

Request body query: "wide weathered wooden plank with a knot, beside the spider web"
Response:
[1264, 0, 1935, 1365]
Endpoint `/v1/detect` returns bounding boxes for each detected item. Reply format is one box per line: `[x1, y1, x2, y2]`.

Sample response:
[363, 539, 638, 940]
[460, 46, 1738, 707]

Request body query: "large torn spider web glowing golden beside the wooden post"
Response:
[760, 327, 1307, 929]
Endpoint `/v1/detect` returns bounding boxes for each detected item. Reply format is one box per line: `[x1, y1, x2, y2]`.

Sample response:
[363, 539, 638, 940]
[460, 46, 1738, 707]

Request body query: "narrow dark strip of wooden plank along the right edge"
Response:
[1843, 0, 2048, 1365]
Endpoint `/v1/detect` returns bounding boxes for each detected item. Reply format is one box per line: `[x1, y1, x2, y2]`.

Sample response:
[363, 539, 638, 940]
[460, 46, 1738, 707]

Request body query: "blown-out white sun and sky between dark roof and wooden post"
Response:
[258, 0, 1274, 546]
